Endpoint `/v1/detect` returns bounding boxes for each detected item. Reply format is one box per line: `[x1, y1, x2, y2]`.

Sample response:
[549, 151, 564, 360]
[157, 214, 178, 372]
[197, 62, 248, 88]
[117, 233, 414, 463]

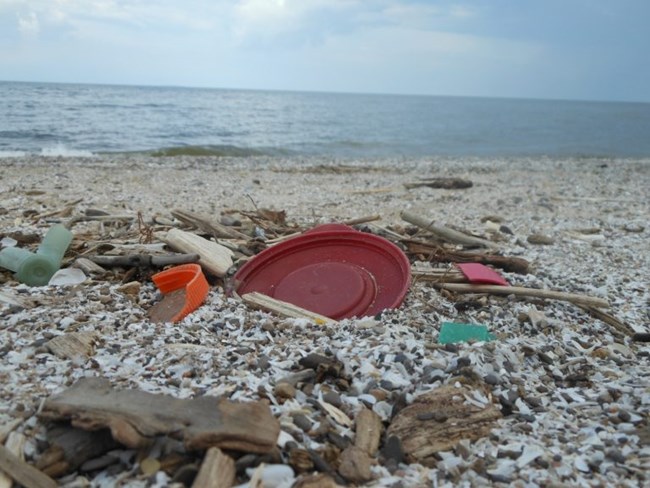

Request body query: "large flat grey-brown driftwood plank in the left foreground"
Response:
[40, 378, 280, 453]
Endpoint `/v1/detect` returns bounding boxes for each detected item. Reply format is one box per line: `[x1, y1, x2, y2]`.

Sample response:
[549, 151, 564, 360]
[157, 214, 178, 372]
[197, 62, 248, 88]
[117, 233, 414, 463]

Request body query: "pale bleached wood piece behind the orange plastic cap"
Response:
[161, 229, 233, 277]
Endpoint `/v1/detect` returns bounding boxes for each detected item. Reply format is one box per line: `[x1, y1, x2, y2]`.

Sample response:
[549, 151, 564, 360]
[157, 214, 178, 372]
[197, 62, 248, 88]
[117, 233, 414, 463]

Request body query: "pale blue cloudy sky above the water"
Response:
[0, 0, 650, 102]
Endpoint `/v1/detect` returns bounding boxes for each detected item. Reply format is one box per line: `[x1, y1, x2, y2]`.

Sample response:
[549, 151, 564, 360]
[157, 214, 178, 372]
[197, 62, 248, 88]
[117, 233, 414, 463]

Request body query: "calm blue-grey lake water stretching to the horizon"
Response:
[0, 82, 650, 158]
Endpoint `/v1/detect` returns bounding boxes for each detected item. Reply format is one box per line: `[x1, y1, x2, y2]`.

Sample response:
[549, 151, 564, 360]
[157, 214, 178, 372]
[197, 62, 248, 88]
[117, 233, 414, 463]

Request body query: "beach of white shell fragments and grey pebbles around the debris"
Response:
[0, 155, 650, 487]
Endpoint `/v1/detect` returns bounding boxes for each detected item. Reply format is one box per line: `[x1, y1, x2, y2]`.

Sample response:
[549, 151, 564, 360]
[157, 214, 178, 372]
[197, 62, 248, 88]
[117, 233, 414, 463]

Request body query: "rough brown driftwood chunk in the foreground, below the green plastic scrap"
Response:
[386, 385, 501, 466]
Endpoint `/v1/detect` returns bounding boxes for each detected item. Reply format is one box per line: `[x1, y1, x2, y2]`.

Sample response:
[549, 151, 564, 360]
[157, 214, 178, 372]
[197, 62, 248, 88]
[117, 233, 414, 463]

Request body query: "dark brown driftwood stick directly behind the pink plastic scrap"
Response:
[402, 239, 530, 274]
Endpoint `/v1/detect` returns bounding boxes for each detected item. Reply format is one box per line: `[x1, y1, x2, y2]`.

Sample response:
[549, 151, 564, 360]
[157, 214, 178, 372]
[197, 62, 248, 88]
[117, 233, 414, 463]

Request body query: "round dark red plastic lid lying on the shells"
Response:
[235, 224, 411, 320]
